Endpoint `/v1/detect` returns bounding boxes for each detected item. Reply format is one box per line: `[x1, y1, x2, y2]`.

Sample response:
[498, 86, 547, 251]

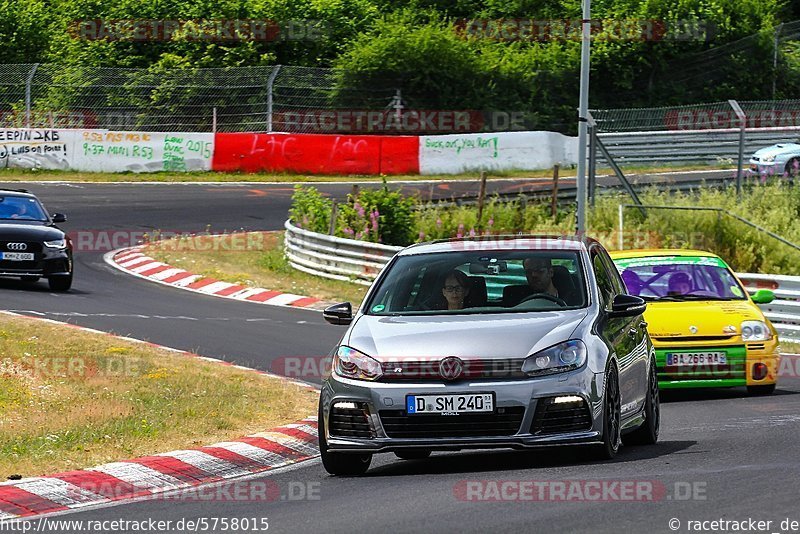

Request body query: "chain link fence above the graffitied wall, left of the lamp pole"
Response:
[0, 64, 398, 132]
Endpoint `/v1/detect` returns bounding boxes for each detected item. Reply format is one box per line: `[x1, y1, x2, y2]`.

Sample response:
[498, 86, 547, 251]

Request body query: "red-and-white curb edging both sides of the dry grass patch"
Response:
[0, 311, 319, 522]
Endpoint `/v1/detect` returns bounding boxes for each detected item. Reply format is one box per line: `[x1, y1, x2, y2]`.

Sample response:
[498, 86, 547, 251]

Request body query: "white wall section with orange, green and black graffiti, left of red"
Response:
[0, 129, 214, 172]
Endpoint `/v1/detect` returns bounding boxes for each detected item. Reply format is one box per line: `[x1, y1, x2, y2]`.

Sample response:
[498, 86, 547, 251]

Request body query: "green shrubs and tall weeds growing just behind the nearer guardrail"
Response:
[291, 183, 800, 274]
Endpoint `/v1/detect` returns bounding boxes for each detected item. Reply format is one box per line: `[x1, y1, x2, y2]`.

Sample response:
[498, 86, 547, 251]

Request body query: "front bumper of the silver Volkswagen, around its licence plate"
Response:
[320, 367, 603, 453]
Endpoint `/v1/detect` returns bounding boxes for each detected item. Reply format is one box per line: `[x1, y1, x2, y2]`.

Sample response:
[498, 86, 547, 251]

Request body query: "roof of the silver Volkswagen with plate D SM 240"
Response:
[398, 235, 597, 256]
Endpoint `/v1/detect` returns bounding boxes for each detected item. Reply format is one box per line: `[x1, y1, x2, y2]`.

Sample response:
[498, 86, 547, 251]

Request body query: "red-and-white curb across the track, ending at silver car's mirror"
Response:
[104, 247, 333, 310]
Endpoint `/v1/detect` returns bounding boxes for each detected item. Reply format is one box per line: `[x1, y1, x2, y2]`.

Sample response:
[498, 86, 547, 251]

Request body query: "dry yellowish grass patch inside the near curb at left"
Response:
[0, 315, 316, 480]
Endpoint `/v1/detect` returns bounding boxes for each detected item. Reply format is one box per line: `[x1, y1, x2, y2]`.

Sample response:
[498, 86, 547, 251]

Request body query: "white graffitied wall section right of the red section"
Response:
[419, 132, 578, 174]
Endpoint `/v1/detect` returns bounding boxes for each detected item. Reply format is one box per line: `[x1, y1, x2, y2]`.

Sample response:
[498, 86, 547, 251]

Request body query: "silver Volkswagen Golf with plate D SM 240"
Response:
[319, 236, 659, 475]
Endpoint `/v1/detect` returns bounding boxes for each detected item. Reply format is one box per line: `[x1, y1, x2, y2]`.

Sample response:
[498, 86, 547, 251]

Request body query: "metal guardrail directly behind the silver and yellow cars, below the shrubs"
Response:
[284, 220, 800, 343]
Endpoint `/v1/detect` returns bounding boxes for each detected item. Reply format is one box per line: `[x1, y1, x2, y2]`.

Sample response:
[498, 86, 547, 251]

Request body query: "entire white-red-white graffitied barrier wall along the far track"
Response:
[0, 128, 577, 175]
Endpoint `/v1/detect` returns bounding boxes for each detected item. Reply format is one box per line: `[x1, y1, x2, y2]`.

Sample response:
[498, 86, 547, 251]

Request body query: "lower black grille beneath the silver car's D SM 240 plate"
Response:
[379, 406, 525, 438]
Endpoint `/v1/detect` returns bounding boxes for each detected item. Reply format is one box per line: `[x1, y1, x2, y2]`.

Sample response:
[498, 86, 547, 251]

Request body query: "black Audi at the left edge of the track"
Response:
[0, 189, 72, 291]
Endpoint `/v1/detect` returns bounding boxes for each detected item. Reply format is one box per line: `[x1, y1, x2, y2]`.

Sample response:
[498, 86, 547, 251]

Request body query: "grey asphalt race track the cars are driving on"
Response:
[0, 174, 800, 533]
